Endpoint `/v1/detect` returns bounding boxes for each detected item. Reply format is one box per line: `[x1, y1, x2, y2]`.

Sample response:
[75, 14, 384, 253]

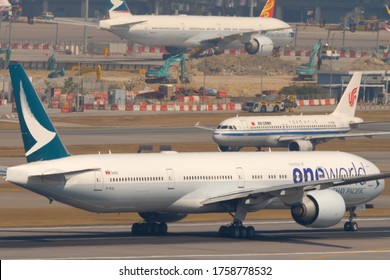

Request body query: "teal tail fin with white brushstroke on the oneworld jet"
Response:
[9, 64, 69, 162]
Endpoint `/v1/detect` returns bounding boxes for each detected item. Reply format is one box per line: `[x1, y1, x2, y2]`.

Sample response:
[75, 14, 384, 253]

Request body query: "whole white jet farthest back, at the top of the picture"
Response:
[56, 0, 294, 58]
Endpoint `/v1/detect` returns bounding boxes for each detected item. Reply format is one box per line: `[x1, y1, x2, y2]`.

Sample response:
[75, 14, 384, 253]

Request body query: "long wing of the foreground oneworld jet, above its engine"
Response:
[201, 172, 390, 205]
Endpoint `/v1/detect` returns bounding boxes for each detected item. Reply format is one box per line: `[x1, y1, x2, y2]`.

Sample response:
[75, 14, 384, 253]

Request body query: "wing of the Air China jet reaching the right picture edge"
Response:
[278, 131, 390, 142]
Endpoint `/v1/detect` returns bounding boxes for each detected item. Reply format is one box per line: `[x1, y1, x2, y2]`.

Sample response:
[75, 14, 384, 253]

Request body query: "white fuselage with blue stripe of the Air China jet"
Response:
[213, 115, 362, 147]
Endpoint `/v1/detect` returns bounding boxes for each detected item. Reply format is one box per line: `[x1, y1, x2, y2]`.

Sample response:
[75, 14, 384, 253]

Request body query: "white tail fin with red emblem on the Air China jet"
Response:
[332, 72, 362, 117]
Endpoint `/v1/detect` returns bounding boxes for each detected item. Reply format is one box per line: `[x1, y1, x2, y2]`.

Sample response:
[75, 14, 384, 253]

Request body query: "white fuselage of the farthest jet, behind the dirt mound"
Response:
[99, 15, 294, 48]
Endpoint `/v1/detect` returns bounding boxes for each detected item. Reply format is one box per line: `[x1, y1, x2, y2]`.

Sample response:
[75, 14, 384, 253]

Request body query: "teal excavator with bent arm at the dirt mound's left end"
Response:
[145, 54, 190, 84]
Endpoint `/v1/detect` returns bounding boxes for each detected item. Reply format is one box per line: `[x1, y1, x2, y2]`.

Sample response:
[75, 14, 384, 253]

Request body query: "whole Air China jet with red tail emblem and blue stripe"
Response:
[195, 72, 390, 152]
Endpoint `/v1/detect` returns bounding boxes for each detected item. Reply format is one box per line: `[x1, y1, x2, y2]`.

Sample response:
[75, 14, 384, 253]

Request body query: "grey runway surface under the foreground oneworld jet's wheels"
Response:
[0, 218, 390, 260]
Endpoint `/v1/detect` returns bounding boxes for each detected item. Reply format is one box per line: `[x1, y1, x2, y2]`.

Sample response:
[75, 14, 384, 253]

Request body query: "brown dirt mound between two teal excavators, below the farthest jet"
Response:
[190, 54, 298, 76]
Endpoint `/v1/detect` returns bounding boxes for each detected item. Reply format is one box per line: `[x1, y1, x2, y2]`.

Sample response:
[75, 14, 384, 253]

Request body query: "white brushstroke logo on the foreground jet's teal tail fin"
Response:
[20, 81, 56, 156]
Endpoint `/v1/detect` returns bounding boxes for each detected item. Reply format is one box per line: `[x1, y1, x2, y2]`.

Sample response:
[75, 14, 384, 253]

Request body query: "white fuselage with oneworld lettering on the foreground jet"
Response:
[6, 152, 384, 213]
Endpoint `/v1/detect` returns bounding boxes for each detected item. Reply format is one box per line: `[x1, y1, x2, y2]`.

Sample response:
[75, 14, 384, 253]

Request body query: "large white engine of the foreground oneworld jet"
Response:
[291, 189, 346, 228]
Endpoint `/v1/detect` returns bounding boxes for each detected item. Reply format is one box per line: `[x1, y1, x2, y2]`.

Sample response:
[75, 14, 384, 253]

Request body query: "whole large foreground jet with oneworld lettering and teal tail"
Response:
[0, 64, 390, 238]
